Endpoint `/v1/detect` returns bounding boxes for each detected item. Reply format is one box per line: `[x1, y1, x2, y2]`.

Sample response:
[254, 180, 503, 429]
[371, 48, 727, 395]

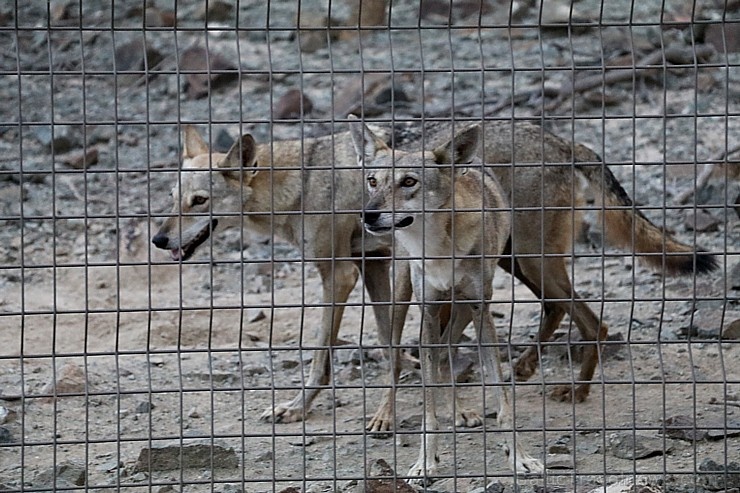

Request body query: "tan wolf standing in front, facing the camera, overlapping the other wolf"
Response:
[351, 121, 543, 483]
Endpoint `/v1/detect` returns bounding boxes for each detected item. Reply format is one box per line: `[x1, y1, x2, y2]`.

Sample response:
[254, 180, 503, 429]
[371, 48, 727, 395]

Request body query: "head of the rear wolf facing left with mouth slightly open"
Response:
[152, 125, 257, 260]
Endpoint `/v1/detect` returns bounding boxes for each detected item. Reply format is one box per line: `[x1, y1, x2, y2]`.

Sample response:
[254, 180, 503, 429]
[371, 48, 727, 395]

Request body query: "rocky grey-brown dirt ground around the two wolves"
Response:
[0, 0, 740, 493]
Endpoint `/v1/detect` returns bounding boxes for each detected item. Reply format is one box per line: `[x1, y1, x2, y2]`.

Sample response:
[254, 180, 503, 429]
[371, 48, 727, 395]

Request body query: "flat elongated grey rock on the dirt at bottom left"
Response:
[134, 442, 239, 472]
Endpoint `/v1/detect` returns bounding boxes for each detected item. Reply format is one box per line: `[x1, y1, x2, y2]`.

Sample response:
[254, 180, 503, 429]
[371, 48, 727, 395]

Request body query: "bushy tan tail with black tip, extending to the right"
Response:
[576, 147, 718, 275]
